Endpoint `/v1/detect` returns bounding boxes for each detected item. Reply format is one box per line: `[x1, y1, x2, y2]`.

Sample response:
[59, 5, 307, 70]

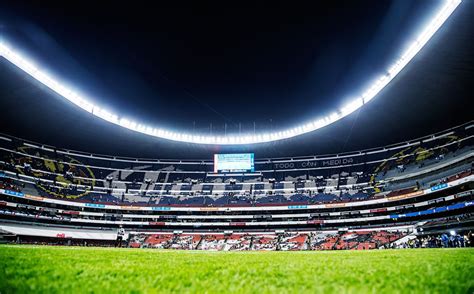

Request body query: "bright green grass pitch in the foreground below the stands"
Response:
[0, 246, 474, 293]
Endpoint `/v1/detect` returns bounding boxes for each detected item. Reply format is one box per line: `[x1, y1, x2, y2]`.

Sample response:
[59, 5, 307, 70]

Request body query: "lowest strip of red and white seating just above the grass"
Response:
[129, 231, 404, 251]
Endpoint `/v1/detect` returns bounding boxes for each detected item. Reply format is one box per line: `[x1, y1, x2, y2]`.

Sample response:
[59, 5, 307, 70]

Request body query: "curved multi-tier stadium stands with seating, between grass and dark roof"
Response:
[0, 123, 474, 251]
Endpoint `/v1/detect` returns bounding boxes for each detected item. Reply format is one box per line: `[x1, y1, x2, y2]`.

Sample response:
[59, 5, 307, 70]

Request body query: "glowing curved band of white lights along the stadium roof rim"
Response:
[0, 0, 461, 145]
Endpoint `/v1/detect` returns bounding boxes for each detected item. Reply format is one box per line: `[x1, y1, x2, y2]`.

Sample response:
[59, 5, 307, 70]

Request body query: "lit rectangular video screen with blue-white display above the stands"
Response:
[214, 153, 255, 173]
